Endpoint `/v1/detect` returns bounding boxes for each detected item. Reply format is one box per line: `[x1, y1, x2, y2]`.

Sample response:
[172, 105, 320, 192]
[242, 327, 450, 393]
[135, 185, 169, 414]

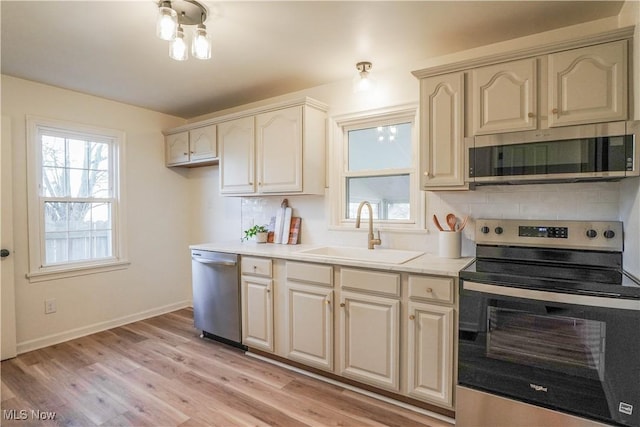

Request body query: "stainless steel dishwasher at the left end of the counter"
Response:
[191, 250, 244, 348]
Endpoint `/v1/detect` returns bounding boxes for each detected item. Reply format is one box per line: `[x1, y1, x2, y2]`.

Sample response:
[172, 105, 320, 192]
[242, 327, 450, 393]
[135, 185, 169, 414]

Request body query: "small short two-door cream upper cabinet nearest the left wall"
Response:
[165, 124, 218, 167]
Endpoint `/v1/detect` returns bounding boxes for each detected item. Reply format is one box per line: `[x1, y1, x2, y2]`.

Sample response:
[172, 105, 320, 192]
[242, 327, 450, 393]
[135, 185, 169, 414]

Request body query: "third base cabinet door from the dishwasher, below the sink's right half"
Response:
[340, 292, 400, 391]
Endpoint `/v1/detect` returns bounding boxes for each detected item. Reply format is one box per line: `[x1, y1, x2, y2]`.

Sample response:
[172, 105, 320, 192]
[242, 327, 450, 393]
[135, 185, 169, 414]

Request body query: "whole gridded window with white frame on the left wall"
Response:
[28, 118, 124, 280]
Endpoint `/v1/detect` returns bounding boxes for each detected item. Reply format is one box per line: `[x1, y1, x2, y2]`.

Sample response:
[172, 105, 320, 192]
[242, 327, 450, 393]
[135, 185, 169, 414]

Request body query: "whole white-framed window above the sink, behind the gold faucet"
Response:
[332, 107, 423, 228]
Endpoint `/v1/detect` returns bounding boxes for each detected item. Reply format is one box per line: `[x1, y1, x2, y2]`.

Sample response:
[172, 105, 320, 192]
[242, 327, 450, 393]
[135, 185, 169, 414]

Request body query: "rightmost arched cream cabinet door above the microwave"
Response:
[548, 40, 629, 127]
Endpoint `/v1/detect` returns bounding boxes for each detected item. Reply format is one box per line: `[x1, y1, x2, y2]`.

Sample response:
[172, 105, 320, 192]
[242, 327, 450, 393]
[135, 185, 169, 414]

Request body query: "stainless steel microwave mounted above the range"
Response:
[465, 121, 640, 185]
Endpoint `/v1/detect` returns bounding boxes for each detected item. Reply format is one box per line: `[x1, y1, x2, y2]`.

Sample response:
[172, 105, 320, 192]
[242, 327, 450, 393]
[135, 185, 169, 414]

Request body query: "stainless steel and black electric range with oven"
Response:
[456, 220, 640, 427]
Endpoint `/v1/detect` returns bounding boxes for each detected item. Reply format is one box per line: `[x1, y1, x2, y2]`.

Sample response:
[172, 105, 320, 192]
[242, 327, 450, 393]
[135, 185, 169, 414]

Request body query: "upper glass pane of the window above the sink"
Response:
[348, 123, 412, 171]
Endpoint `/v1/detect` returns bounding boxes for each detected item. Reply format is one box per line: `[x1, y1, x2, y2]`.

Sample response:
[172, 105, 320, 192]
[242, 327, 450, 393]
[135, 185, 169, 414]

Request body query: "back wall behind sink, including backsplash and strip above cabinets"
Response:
[192, 16, 640, 271]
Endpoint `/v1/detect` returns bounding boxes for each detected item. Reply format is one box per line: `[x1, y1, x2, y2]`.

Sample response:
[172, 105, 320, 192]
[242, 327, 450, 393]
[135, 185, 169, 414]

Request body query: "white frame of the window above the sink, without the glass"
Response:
[329, 104, 427, 233]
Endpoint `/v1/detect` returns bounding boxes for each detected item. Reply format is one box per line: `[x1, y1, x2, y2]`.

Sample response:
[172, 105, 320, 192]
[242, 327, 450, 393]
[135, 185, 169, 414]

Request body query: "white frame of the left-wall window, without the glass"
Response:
[26, 116, 130, 282]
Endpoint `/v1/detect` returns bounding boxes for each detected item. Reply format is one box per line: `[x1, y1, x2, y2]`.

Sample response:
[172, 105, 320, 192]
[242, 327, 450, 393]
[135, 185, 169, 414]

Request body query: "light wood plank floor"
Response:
[0, 309, 451, 427]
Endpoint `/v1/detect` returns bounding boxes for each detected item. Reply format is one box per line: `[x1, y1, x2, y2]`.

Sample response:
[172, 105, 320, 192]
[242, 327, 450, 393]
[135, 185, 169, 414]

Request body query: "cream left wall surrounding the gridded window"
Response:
[2, 75, 191, 352]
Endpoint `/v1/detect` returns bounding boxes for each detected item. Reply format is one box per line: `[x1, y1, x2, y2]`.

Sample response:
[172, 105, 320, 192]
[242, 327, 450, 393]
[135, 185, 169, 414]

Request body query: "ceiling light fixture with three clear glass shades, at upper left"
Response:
[156, 0, 211, 61]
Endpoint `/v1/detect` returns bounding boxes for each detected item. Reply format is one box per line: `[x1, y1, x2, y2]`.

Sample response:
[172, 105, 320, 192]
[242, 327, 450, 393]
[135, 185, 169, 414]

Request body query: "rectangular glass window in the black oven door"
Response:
[487, 307, 606, 378]
